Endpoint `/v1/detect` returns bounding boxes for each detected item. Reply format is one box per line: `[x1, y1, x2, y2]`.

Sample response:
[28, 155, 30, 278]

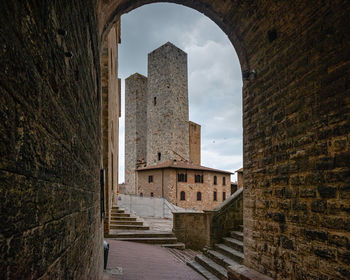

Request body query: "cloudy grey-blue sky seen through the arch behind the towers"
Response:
[119, 3, 242, 183]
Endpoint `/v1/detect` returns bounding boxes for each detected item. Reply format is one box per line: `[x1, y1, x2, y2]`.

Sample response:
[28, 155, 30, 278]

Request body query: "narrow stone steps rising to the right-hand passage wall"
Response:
[187, 226, 244, 280]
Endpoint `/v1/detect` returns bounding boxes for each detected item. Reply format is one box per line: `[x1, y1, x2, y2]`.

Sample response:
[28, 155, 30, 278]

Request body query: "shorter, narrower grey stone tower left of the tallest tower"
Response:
[125, 73, 147, 194]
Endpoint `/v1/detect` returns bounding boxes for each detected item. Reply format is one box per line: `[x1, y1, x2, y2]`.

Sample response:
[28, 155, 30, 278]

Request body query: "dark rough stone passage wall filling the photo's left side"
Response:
[0, 0, 103, 279]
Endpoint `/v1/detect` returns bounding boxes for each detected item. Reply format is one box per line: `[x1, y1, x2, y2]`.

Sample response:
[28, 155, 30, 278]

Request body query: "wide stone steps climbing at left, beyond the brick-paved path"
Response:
[107, 206, 185, 249]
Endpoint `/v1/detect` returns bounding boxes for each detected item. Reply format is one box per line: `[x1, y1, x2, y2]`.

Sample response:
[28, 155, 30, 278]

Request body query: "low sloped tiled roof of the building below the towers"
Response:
[136, 160, 233, 174]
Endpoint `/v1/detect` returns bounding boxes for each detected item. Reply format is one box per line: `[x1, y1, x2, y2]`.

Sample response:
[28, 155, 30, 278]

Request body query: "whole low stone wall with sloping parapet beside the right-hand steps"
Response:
[173, 189, 243, 250]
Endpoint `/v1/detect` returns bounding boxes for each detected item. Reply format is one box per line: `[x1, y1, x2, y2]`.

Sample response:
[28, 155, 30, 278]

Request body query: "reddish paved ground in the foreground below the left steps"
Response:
[103, 239, 204, 280]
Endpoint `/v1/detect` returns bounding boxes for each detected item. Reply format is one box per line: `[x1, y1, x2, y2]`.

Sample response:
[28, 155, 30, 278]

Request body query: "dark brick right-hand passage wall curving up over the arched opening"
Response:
[99, 0, 350, 278]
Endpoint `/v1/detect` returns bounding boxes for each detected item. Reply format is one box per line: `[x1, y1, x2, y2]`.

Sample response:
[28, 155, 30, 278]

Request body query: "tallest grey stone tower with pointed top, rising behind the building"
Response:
[147, 42, 189, 165]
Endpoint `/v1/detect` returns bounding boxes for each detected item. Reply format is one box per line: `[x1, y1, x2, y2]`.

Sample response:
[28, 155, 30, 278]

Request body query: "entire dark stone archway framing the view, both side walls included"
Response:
[0, 0, 350, 279]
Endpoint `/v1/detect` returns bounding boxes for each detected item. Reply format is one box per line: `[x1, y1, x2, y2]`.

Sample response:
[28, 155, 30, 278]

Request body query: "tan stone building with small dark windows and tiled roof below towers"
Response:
[137, 160, 231, 210]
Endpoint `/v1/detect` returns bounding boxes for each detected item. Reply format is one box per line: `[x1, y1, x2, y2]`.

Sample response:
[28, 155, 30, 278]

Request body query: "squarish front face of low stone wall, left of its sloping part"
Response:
[173, 211, 212, 250]
